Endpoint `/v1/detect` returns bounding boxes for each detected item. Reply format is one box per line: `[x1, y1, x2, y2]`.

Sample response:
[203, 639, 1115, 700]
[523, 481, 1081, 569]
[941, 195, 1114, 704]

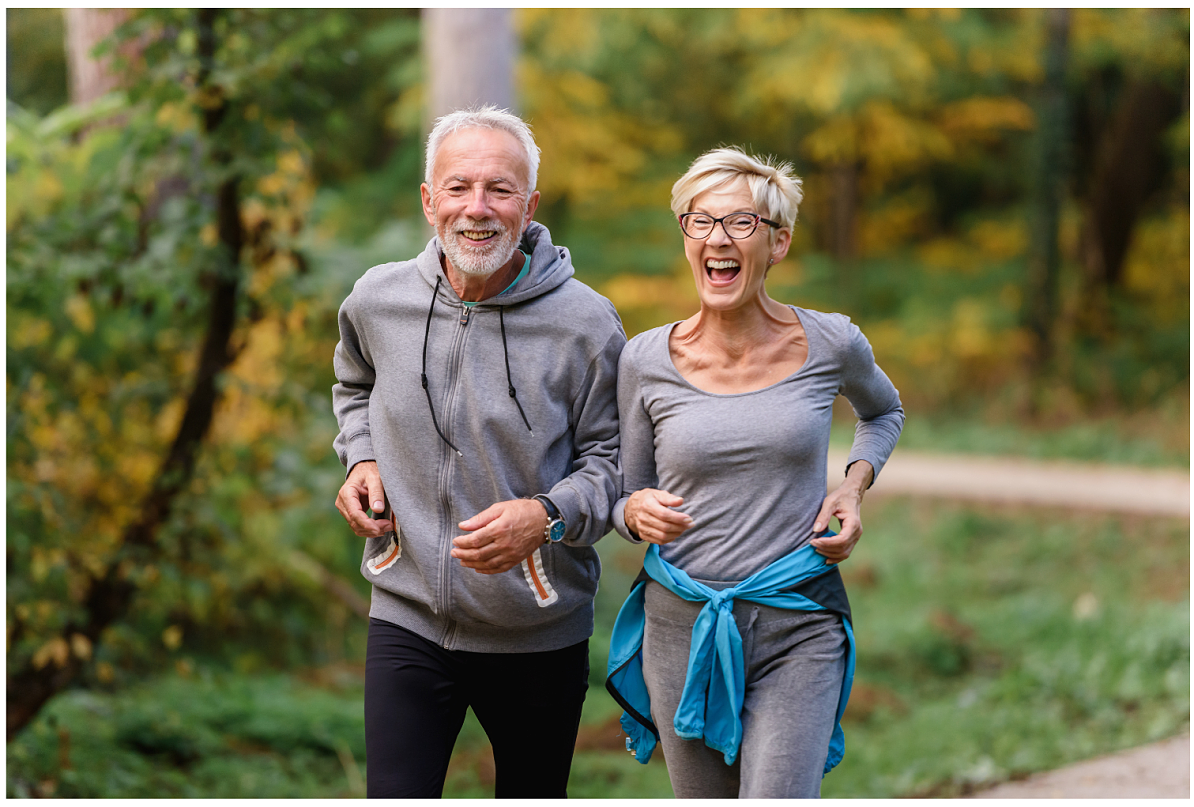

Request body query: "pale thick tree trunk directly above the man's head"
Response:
[423, 8, 517, 119]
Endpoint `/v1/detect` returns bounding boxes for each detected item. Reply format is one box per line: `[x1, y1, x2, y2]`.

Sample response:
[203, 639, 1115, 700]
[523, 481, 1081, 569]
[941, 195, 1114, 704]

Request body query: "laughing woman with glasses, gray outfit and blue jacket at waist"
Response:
[607, 148, 904, 799]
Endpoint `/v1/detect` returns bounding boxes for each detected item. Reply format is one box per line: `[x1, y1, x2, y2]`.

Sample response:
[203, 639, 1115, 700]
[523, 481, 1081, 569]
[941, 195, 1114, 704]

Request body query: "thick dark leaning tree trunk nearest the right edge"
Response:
[1079, 79, 1182, 335]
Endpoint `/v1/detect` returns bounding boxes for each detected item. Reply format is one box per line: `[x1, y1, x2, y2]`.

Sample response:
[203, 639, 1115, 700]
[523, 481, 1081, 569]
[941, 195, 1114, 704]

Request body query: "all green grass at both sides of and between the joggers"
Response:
[7, 499, 1190, 797]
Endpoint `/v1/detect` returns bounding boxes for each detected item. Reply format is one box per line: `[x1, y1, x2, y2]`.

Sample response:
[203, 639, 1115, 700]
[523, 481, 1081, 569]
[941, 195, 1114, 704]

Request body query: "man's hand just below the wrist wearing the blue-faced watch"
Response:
[451, 499, 547, 574]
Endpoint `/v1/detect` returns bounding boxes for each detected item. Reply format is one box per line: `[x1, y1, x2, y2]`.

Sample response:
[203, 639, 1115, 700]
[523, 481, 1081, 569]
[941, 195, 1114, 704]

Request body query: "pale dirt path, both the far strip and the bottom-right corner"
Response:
[830, 449, 1190, 799]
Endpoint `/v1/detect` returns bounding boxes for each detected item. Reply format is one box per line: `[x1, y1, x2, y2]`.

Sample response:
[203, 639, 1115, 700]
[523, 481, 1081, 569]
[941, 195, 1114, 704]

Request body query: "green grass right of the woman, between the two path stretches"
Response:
[824, 500, 1189, 796]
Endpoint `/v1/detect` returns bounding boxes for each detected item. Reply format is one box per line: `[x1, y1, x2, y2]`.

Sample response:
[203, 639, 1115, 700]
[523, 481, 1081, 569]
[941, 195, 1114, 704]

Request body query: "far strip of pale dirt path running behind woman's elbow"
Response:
[829, 449, 1190, 518]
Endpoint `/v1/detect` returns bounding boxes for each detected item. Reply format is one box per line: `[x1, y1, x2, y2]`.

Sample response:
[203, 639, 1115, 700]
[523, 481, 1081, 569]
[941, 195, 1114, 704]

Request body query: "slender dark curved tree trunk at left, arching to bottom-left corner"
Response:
[7, 8, 245, 739]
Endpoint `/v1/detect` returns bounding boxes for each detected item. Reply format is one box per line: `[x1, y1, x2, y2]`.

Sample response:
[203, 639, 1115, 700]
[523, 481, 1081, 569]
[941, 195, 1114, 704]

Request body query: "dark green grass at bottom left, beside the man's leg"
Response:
[7, 673, 364, 799]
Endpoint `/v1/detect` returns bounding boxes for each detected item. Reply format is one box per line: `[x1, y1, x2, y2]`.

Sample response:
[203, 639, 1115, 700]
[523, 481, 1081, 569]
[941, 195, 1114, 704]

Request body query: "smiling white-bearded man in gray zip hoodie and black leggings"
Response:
[333, 107, 626, 797]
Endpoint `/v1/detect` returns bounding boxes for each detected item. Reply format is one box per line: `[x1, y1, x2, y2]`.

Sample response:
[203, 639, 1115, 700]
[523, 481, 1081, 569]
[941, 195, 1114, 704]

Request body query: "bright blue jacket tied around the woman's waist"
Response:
[605, 544, 854, 774]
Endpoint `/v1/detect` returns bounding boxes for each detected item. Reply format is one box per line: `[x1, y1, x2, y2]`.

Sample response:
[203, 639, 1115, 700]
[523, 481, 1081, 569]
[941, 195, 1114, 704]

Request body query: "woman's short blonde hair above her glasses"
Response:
[672, 146, 805, 238]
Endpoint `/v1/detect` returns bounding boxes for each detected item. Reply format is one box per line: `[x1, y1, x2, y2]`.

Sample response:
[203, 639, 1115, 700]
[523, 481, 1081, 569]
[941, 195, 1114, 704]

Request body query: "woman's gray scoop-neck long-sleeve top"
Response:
[614, 307, 904, 583]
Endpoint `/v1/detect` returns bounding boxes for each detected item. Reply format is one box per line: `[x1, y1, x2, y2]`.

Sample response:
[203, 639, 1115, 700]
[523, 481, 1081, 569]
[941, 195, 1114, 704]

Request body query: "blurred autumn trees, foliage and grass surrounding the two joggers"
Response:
[6, 10, 1190, 796]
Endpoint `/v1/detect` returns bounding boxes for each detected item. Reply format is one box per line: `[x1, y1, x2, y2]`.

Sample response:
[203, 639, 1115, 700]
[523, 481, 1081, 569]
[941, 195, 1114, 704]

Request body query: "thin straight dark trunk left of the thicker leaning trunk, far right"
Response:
[1026, 8, 1070, 375]
